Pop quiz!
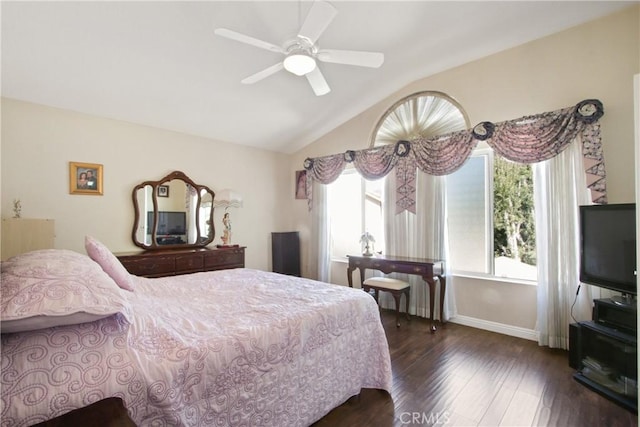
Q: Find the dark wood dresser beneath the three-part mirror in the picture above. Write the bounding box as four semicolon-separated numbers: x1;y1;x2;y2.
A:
115;246;245;277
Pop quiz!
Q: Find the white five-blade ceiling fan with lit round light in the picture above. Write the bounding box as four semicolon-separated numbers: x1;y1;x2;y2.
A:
214;0;384;96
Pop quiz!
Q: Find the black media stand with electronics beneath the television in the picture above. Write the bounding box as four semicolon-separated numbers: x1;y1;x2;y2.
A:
569;300;638;412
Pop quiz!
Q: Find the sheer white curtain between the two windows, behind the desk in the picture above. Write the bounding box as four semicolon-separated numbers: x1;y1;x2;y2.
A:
380;171;456;320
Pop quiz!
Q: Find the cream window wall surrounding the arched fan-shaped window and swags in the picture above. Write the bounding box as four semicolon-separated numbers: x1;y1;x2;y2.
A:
289;5;640;330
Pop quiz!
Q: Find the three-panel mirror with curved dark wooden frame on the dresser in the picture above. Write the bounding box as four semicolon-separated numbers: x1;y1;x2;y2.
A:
132;171;215;250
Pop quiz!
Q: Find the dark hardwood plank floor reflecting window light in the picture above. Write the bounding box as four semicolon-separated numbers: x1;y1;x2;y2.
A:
314;310;638;427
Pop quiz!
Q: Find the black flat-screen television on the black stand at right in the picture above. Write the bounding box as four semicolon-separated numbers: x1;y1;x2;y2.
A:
580;203;637;297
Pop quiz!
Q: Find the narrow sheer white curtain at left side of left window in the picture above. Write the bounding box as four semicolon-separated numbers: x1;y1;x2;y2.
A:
308;181;331;282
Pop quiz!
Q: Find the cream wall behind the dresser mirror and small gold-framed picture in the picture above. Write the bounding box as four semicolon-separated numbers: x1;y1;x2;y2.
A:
1;99;293;270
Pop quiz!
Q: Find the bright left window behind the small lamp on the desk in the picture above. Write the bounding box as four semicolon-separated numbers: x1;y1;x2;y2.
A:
327;169;384;260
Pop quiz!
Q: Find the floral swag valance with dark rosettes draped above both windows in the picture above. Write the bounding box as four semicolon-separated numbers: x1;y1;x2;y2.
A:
304;99;607;213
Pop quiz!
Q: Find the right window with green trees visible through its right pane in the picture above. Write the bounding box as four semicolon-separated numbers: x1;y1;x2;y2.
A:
446;145;537;281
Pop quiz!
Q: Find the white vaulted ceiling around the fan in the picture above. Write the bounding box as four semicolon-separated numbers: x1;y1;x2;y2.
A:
1;1;633;153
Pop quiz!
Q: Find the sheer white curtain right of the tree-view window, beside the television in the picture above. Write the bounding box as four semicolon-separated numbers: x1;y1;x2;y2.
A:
534;137;599;349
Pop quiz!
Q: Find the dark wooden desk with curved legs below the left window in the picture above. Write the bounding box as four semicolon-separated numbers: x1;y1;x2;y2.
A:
347;255;446;332
